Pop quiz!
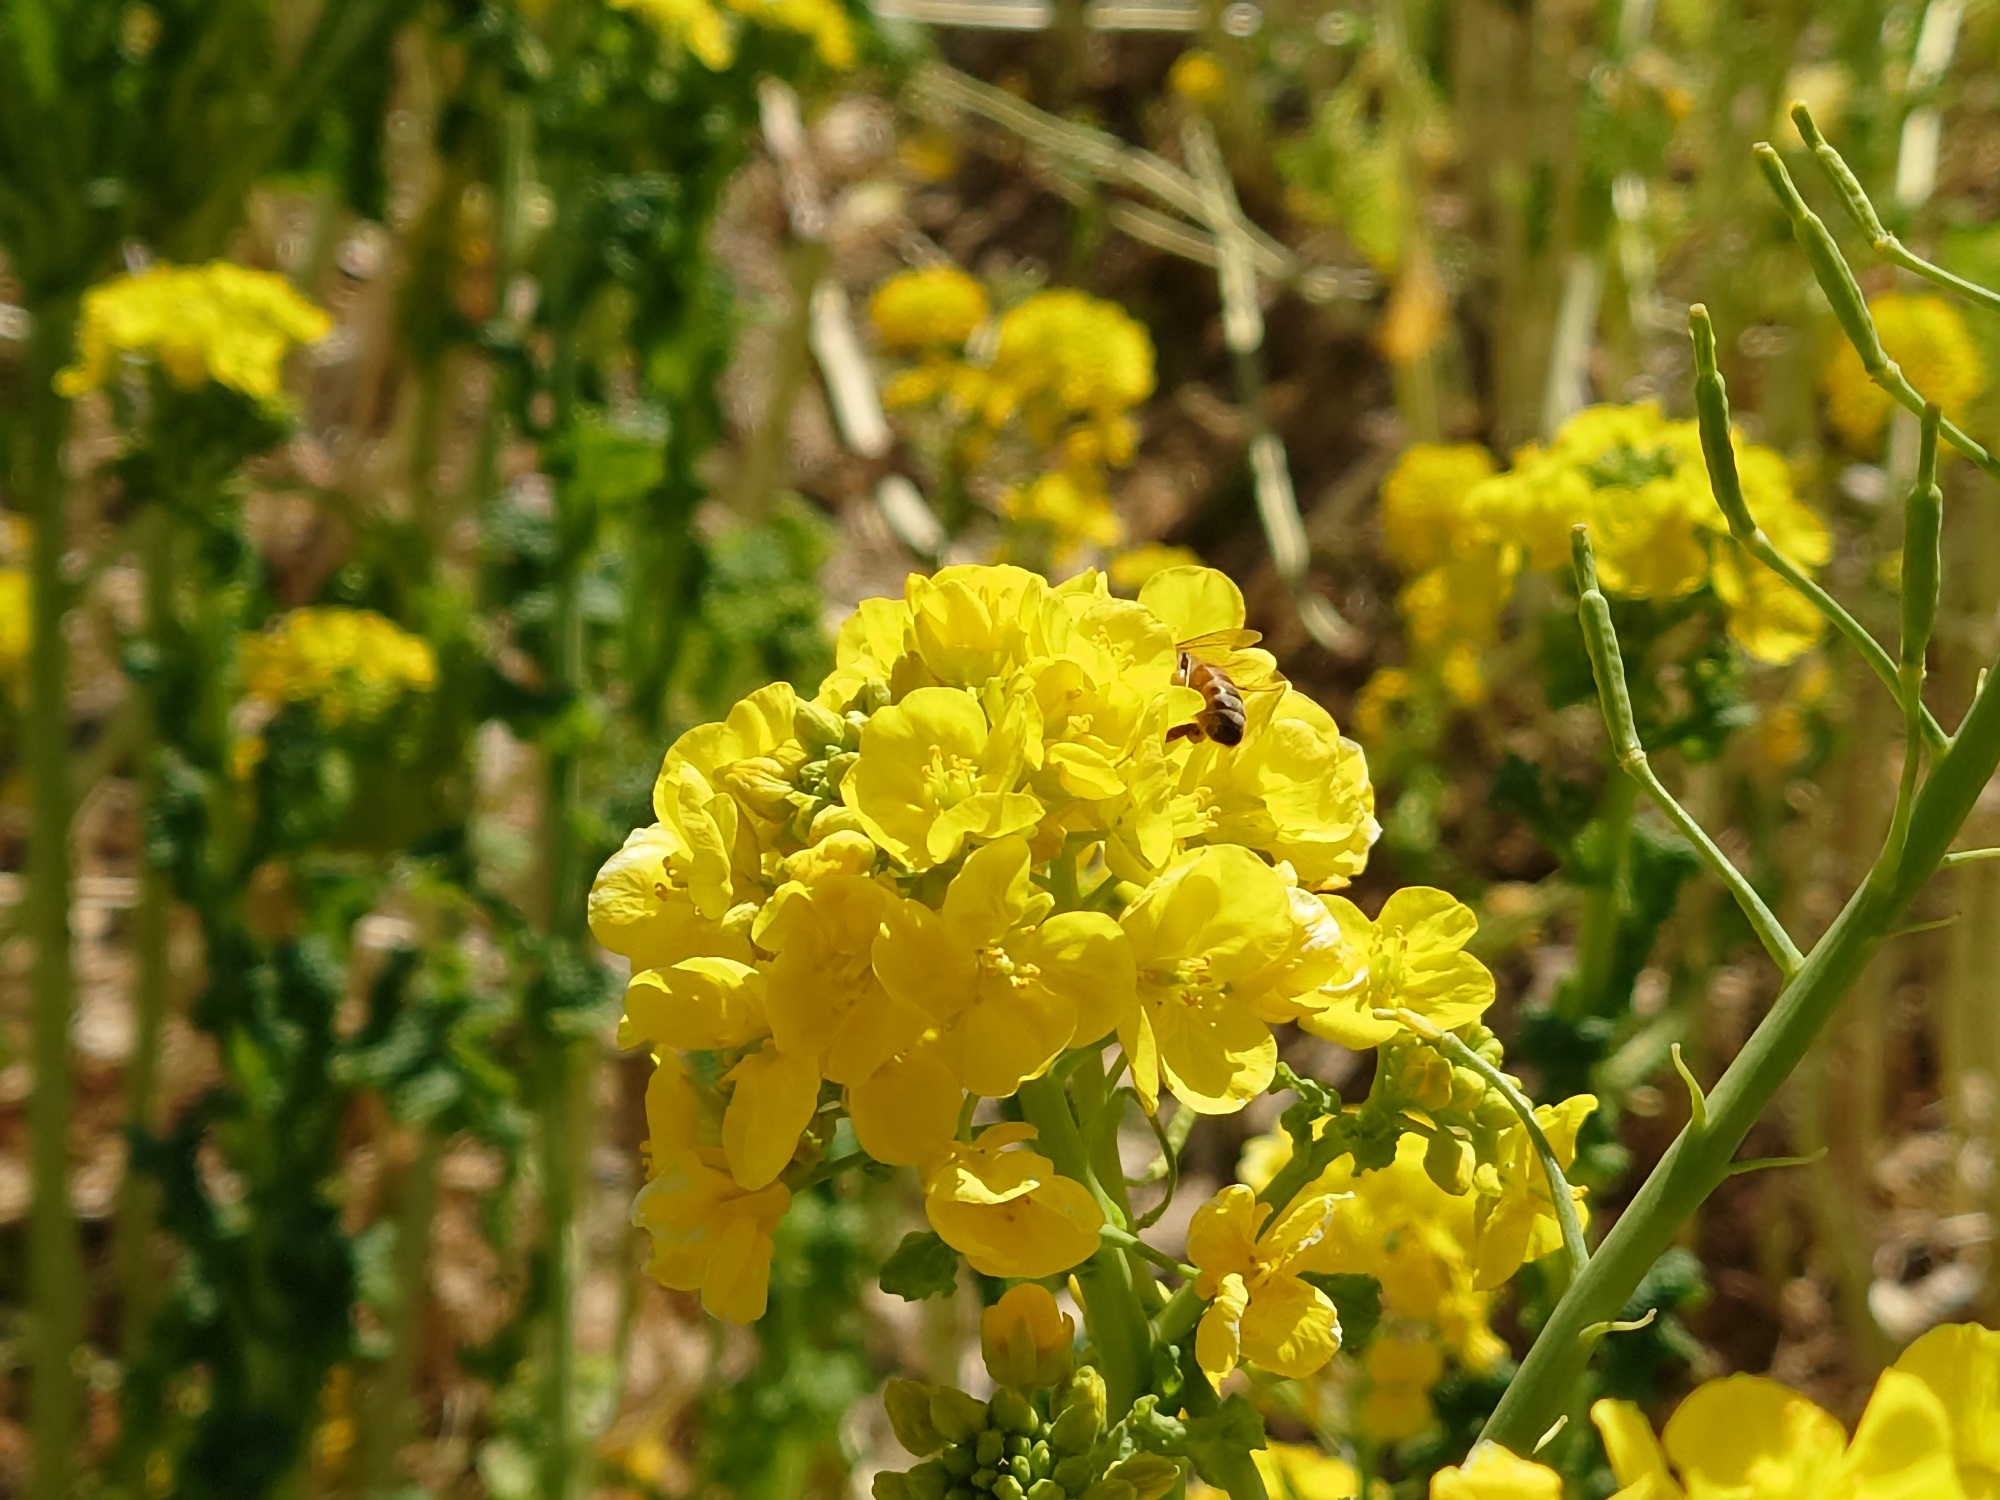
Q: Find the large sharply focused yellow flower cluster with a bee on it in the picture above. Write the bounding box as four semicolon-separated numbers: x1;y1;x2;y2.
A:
590;566;1392;1320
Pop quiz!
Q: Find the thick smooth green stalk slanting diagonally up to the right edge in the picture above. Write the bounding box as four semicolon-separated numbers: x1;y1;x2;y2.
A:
1484;644;2000;1452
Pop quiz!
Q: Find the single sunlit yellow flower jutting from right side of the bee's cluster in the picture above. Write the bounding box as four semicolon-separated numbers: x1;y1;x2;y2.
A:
1300;886;1494;1048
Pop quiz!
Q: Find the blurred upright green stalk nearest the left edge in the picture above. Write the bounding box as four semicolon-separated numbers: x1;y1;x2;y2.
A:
20;312;84;1500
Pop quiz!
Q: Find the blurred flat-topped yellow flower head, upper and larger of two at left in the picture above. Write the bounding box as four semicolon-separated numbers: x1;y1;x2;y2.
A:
56;260;334;404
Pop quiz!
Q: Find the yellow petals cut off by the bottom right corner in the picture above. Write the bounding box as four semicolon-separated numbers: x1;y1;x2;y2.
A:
1430;1324;2000;1500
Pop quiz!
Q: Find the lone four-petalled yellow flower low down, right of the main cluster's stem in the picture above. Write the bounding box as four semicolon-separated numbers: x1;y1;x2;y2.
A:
1188;1182;1340;1382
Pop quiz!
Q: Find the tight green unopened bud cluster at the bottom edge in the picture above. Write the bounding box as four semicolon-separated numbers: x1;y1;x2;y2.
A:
874;1366;1182;1500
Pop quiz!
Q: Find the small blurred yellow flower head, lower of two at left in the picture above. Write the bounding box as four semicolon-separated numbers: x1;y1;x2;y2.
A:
242;606;438;724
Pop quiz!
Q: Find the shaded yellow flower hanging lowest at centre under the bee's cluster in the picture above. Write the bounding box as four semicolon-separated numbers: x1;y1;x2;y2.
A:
924;1124;1104;1280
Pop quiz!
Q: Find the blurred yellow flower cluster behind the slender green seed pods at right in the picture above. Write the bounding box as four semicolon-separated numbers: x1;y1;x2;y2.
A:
1356;402;1832;732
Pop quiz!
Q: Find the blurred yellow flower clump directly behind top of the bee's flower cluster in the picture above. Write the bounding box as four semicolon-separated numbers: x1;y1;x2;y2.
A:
868;266;1154;564
